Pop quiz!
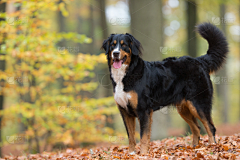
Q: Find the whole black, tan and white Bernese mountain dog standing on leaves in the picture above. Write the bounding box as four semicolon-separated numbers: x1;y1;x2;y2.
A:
102;23;228;154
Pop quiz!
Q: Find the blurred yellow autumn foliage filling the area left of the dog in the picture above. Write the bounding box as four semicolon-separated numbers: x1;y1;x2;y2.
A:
0;0;117;151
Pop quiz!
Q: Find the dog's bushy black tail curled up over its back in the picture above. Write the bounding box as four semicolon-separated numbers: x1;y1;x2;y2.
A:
197;23;228;73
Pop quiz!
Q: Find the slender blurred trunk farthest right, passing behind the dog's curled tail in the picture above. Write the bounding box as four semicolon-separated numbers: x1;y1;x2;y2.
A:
217;4;229;123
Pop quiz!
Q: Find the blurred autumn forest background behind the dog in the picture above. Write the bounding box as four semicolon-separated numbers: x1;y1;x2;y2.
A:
0;0;240;156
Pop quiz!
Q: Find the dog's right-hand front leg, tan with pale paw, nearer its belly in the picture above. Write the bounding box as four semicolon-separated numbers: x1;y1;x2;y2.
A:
138;111;153;154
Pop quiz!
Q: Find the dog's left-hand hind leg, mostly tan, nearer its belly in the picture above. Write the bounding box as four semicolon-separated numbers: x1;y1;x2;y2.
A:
177;101;200;146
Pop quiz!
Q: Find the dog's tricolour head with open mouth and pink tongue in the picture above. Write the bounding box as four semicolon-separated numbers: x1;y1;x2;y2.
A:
102;33;142;69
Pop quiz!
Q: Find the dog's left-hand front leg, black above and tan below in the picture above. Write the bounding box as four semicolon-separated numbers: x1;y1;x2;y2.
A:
118;106;136;153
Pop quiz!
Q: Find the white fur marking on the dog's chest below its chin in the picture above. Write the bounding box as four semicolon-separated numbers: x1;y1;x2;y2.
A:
111;64;131;109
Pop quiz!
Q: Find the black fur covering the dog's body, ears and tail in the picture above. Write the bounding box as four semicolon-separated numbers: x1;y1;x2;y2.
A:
103;23;228;152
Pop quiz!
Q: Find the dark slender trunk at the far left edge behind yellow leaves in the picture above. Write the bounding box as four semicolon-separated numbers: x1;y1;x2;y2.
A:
0;3;6;157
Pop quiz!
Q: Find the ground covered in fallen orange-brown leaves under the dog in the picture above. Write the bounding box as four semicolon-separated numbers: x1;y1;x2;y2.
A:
5;134;240;160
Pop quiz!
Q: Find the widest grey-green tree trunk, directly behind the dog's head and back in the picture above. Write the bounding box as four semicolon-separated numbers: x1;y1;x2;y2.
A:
129;0;167;140
